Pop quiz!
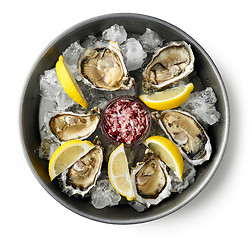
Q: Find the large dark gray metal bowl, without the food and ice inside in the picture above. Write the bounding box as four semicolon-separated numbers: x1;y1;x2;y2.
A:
21;14;229;224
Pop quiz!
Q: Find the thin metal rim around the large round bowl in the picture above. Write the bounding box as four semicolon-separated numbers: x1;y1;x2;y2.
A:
19;13;230;224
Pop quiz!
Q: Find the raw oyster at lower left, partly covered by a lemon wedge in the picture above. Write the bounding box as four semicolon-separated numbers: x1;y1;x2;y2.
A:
59;136;103;197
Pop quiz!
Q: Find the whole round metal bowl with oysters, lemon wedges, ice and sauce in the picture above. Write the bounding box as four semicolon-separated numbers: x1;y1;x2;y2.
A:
21;14;229;224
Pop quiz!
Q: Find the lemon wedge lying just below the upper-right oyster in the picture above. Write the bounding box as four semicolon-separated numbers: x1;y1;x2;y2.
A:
139;83;194;110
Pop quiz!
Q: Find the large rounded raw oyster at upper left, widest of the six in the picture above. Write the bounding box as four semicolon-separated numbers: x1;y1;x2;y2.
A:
78;41;135;91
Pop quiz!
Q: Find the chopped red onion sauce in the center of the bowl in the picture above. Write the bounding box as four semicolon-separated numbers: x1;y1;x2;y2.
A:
104;99;149;144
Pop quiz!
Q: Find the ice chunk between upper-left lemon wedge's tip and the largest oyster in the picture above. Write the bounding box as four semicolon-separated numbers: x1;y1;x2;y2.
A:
62;41;83;66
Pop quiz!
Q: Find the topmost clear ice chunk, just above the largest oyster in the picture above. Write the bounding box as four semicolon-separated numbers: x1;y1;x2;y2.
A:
102;24;127;45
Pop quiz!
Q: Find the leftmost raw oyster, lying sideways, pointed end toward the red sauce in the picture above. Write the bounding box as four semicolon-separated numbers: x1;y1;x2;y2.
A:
45;107;100;143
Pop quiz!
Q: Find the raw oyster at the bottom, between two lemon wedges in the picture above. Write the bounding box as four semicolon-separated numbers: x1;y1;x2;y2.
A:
131;149;171;207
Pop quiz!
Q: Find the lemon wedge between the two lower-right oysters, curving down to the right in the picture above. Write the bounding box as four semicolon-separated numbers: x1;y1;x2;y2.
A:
143;136;184;180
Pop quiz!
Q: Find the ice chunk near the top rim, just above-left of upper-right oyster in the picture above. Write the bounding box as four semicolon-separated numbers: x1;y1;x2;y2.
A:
139;28;163;52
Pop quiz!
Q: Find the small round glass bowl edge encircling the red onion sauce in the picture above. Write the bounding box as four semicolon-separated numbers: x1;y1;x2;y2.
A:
101;96;151;148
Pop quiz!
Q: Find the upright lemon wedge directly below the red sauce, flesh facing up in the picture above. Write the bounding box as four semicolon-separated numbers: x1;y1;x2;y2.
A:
108;143;135;201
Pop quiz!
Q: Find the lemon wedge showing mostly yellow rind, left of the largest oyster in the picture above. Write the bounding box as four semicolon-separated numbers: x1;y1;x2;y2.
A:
56;55;88;108
